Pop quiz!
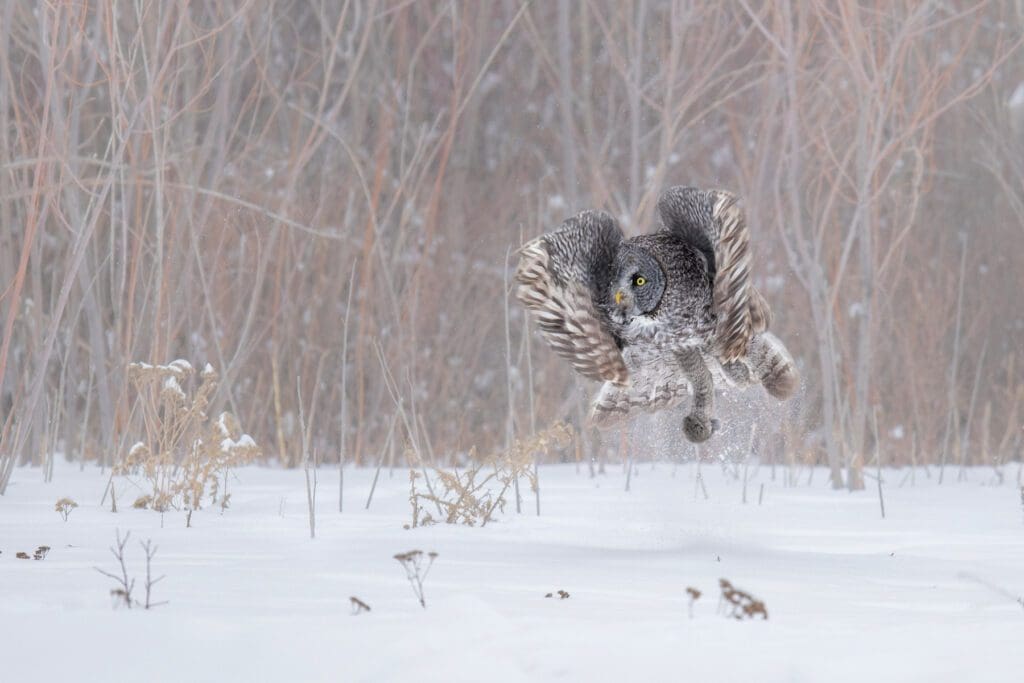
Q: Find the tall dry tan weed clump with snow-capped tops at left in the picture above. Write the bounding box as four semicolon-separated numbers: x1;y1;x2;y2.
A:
115;359;260;523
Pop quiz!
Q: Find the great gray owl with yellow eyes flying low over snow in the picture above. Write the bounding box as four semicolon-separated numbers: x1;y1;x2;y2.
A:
516;187;800;442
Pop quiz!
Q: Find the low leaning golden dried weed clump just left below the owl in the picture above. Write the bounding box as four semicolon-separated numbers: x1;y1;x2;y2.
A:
407;422;573;528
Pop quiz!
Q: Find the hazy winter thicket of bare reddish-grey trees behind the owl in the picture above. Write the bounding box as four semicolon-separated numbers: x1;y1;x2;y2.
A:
0;0;1024;496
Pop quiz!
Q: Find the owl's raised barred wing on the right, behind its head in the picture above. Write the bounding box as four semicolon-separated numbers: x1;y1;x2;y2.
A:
657;186;771;362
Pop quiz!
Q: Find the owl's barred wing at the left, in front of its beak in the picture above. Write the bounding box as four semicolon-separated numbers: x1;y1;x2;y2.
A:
515;211;629;384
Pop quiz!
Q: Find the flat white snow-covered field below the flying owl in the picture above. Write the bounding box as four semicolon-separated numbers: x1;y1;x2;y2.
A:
0;464;1024;683
